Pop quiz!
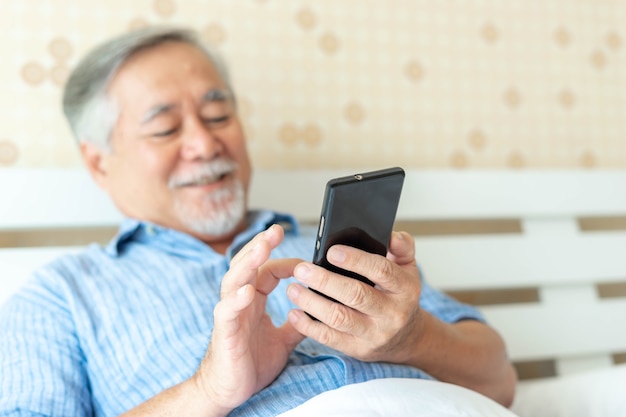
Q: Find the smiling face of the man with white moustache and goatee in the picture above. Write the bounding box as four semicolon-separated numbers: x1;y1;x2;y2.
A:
91;42;251;243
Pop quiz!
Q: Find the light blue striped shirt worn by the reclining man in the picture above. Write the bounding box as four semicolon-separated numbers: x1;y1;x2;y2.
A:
0;211;481;416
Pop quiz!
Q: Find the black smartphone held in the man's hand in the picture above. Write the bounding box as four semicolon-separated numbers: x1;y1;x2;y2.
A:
313;167;404;292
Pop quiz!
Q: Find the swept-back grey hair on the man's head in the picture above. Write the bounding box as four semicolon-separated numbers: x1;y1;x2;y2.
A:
63;26;234;150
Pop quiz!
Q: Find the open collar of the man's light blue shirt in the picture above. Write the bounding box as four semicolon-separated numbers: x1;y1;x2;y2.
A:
105;210;300;259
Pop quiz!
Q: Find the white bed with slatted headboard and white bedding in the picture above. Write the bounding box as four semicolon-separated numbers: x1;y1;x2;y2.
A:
0;169;626;417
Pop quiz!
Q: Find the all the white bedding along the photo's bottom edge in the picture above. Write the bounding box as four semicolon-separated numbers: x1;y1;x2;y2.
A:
280;364;626;417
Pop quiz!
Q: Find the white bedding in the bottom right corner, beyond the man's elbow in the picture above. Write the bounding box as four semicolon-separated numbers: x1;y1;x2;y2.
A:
512;365;626;417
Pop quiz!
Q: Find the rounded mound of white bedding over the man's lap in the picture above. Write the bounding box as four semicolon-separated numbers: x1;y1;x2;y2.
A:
280;378;515;417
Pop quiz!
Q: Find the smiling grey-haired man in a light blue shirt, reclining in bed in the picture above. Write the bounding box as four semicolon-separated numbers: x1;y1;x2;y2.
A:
0;28;515;416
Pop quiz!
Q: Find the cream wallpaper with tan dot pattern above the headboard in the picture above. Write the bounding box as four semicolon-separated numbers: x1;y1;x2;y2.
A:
0;0;626;169
